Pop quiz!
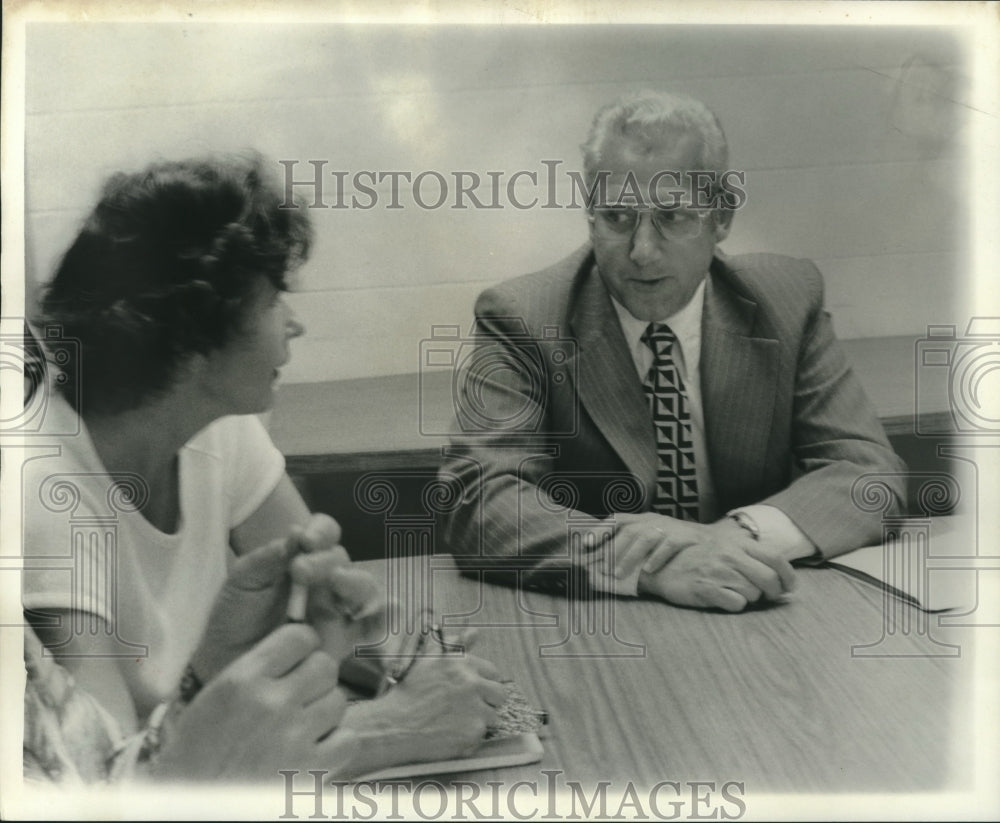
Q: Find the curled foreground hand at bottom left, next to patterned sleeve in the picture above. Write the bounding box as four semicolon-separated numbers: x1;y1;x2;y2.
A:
151;624;347;782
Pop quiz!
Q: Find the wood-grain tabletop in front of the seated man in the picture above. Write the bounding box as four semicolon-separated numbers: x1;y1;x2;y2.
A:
356;555;972;796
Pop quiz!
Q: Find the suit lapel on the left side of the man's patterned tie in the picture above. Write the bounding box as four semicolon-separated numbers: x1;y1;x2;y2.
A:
570;255;656;493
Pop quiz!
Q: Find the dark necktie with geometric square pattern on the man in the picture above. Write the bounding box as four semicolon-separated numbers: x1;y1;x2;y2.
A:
642;323;698;520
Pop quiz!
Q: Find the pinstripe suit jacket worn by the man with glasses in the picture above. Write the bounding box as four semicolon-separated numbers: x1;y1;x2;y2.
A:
441;247;905;577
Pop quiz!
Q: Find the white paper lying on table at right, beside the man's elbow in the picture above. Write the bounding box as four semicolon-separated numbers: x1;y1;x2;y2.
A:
828;516;977;612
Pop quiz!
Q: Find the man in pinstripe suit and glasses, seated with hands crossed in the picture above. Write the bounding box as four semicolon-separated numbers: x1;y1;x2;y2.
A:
442;92;905;612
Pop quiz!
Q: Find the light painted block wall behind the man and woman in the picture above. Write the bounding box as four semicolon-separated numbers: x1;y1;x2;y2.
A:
26;23;969;382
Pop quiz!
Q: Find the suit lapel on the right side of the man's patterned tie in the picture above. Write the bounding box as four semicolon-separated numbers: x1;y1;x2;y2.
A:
701;258;779;508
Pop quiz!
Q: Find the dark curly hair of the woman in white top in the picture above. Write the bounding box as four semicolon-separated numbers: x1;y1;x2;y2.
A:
41;155;312;414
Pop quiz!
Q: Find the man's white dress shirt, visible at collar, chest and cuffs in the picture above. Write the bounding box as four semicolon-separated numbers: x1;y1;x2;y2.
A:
611;276;815;594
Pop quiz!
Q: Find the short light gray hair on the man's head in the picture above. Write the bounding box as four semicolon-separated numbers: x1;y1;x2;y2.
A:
580;90;729;184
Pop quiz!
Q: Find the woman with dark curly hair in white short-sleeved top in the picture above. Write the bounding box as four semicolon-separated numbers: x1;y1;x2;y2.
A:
23;157;504;773
